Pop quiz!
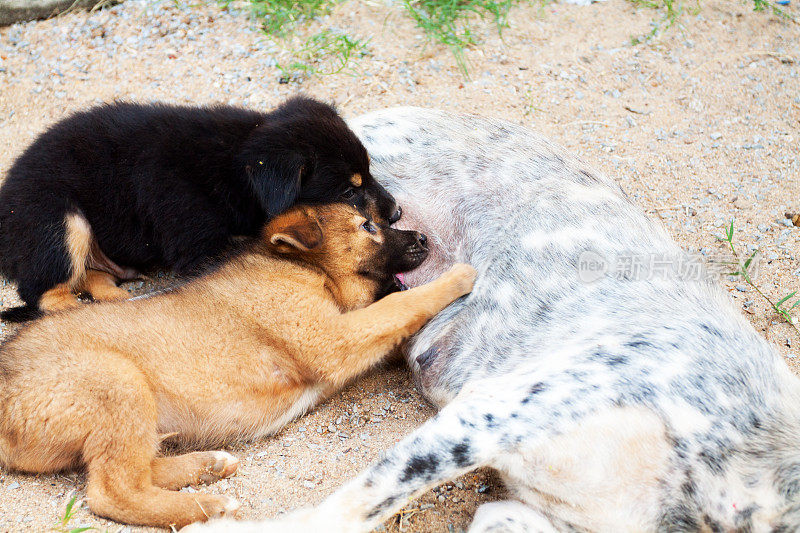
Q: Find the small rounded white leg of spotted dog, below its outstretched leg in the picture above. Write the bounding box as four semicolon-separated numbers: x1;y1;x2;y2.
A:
468;501;559;533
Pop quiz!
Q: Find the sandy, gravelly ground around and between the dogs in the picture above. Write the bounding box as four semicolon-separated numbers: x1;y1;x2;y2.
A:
0;0;800;532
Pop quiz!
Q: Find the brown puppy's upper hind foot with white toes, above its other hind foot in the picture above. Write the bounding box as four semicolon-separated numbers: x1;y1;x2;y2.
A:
151;451;239;490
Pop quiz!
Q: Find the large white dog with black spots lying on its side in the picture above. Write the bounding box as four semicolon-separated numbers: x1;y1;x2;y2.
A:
184;108;800;533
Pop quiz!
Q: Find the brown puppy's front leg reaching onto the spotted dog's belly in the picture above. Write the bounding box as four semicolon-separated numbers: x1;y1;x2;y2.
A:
314;264;477;386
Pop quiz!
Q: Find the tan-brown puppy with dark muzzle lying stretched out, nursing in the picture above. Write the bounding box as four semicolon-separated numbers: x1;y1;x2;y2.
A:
0;205;475;527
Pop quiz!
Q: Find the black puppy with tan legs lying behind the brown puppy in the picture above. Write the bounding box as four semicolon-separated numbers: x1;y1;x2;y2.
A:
0;97;400;321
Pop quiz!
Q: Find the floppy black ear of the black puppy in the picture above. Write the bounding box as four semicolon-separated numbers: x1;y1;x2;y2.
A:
245;153;306;218
